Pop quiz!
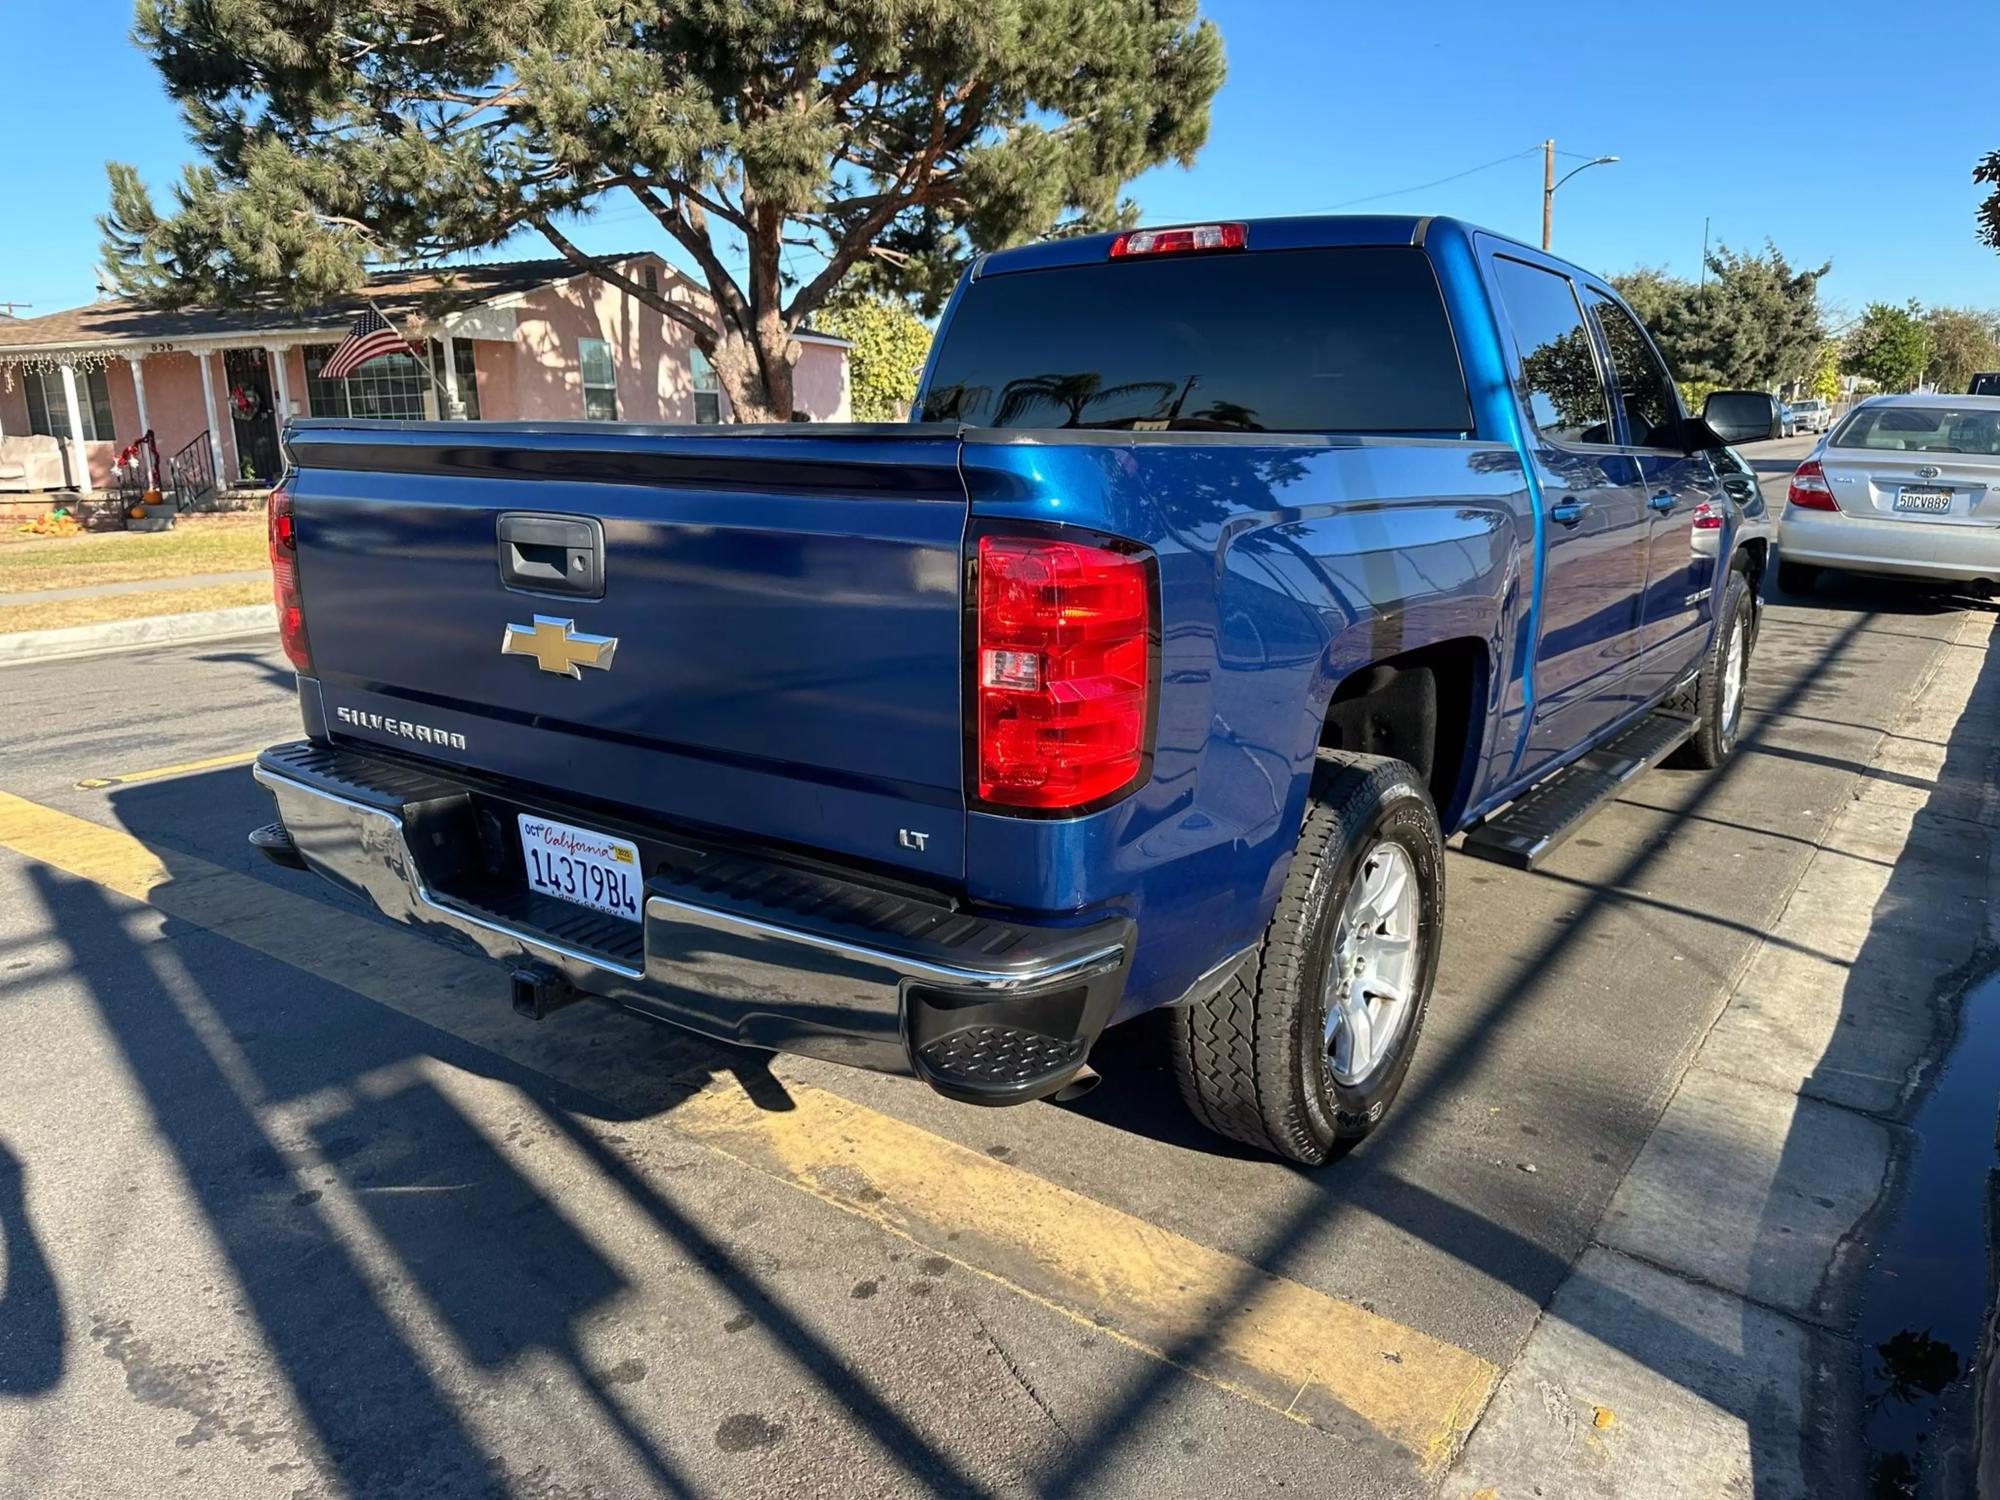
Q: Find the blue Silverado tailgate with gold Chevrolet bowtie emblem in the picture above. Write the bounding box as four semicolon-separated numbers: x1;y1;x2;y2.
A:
290;422;966;880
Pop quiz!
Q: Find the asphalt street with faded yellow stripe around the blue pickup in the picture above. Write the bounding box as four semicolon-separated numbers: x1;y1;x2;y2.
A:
0;442;1976;1500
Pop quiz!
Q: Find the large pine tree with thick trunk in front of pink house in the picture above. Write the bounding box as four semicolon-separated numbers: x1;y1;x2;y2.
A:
102;0;1224;418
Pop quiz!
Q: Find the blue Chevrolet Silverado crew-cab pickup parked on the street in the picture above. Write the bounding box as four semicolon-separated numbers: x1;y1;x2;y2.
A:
252;218;1780;1162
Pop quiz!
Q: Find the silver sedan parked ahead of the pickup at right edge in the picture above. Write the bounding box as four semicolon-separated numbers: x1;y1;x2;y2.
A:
1778;396;2000;594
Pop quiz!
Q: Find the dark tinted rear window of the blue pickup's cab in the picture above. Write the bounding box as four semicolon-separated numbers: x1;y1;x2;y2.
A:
922;246;1472;436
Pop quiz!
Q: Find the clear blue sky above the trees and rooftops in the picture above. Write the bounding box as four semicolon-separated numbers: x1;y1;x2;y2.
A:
0;0;2000;316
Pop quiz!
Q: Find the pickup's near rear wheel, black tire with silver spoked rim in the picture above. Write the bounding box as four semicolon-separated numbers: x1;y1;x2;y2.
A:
1172;752;1444;1166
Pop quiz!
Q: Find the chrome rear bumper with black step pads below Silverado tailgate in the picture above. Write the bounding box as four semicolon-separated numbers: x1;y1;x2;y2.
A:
256;742;1132;1104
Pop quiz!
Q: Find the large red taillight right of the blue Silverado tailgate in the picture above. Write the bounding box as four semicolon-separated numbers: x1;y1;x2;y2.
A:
974;536;1158;810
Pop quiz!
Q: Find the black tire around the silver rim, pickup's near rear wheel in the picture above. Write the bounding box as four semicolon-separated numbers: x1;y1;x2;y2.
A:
1170;750;1444;1166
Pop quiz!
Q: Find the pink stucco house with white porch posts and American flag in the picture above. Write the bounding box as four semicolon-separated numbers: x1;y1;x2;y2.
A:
0;254;850;490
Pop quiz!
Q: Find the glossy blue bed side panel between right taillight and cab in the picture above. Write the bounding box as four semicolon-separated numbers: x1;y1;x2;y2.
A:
962;432;1532;1014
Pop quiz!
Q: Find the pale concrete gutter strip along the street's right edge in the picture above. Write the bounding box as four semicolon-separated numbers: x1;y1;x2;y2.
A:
1444;614;2000;1500
